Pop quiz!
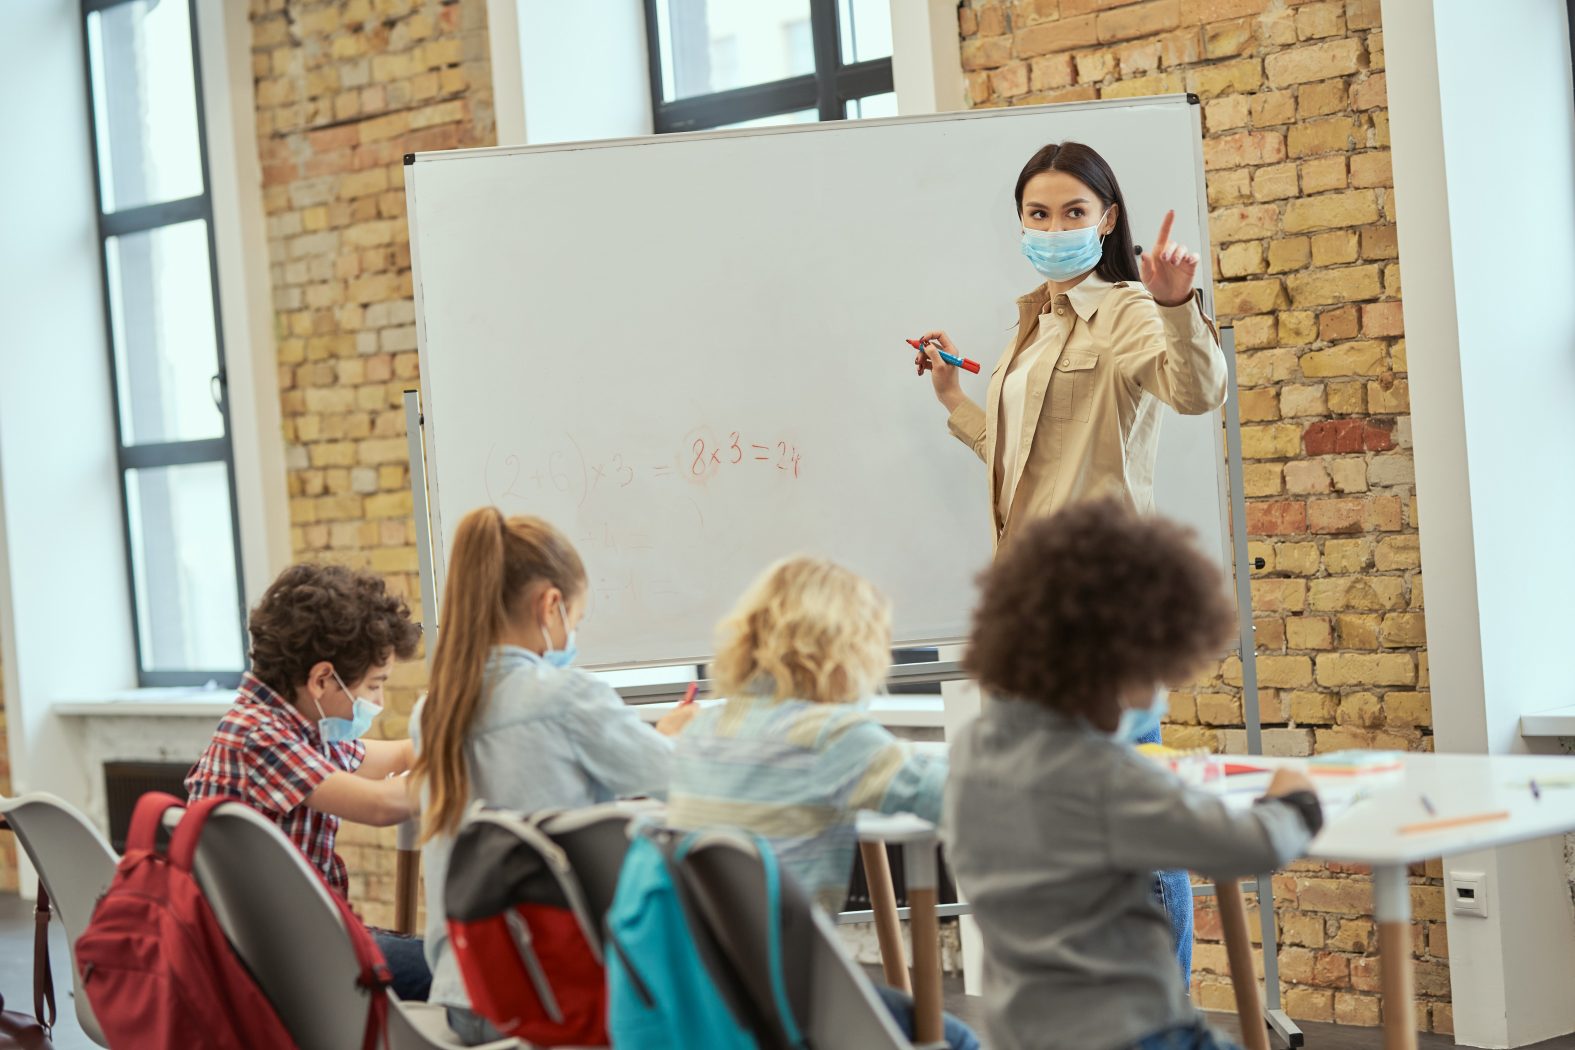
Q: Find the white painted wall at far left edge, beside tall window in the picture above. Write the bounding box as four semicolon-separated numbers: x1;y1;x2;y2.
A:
0;0;135;803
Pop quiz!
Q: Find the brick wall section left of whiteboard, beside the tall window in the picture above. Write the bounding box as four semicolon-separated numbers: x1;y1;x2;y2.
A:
250;0;496;924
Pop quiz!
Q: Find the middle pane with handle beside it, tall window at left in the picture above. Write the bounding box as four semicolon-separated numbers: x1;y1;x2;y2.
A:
104;219;224;446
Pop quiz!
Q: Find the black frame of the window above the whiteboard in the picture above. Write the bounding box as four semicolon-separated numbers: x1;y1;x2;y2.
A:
644;0;895;135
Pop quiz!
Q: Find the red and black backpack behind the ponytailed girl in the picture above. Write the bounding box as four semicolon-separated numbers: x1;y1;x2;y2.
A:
443;808;608;1047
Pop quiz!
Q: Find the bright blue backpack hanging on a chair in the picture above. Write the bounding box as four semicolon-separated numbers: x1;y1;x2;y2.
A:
606;828;805;1050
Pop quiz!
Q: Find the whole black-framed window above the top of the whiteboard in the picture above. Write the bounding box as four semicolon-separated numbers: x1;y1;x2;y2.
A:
646;0;896;132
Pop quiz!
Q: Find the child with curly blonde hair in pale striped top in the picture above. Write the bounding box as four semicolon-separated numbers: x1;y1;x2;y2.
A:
668;557;978;1048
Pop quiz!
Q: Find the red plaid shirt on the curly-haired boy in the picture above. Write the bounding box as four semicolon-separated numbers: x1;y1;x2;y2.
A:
186;672;367;894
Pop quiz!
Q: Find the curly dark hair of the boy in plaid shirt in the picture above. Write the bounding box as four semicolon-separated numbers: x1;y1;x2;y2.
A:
249;562;421;696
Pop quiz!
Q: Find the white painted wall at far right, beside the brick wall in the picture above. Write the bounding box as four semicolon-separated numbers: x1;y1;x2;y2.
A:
1383;0;1575;1047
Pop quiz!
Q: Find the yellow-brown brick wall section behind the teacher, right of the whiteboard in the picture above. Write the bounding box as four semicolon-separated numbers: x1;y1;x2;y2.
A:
958;0;1452;1033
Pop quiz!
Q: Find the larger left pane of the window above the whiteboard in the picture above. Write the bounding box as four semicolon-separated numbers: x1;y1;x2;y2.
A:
657;0;812;102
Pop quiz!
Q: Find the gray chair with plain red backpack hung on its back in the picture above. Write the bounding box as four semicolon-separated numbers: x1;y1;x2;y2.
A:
195;803;520;1050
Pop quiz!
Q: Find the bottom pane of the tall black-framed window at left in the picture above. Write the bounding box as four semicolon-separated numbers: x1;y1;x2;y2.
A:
126;463;244;671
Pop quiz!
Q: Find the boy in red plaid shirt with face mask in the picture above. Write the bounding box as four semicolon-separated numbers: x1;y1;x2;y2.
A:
186;564;432;1000
